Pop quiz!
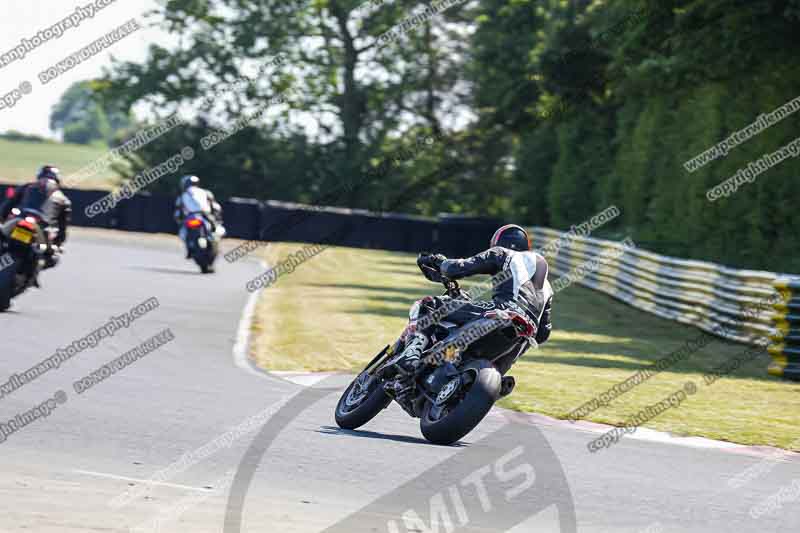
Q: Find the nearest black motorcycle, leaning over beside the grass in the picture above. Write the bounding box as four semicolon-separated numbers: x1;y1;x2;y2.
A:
335;267;536;444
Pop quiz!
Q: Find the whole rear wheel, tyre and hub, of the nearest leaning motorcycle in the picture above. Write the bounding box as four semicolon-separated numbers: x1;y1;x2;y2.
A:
419;359;502;444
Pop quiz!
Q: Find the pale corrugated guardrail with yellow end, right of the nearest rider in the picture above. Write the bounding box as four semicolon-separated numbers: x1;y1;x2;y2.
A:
531;227;800;379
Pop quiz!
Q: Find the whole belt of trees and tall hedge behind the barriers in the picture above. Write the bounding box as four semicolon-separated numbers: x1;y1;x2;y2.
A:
97;0;800;272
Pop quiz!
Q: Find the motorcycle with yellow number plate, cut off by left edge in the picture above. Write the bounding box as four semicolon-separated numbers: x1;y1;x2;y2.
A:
0;208;49;312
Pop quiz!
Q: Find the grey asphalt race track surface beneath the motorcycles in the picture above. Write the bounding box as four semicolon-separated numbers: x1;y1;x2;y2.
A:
0;231;800;533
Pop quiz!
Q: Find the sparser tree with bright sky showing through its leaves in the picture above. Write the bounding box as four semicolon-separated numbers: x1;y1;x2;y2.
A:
104;0;476;206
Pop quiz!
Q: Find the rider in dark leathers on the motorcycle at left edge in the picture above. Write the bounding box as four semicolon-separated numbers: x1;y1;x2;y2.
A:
0;165;72;268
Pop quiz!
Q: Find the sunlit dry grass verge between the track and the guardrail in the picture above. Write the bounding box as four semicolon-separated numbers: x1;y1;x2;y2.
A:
251;244;800;451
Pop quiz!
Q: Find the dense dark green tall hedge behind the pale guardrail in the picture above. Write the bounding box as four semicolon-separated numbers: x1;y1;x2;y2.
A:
468;0;800;272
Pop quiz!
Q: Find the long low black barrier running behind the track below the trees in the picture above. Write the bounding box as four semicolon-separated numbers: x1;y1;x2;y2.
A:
0;184;502;257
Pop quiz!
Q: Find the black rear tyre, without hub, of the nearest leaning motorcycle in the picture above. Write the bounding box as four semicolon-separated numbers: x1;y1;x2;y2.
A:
419;359;501;444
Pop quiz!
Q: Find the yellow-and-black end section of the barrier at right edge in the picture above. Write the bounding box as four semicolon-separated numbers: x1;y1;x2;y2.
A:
769;278;800;380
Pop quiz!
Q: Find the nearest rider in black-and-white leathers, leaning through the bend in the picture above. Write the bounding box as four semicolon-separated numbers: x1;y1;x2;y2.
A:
386;224;553;404
